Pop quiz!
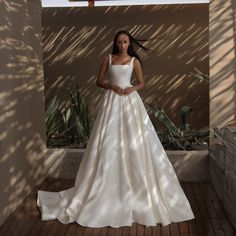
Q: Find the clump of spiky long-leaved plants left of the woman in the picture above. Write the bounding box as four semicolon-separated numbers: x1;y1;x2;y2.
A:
46;84;93;147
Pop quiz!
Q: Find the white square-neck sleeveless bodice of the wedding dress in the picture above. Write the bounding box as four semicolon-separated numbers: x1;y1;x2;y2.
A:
108;54;134;87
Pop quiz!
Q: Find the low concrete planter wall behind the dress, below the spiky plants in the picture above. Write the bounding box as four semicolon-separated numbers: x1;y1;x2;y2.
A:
44;148;209;182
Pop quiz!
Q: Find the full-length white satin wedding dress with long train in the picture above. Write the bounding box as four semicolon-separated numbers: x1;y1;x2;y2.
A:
37;55;194;228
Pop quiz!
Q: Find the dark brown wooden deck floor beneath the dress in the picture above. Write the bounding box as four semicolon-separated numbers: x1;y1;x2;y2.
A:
0;179;236;236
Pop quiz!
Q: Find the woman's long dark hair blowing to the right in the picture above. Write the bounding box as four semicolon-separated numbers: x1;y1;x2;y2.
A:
112;30;151;65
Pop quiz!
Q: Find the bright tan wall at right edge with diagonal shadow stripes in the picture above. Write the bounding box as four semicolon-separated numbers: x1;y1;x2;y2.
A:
209;0;236;127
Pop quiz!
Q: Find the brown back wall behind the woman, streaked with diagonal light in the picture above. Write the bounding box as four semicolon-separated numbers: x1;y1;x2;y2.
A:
42;4;209;128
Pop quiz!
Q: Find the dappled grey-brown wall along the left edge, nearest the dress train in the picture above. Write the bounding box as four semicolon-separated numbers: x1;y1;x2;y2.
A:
0;0;45;225
